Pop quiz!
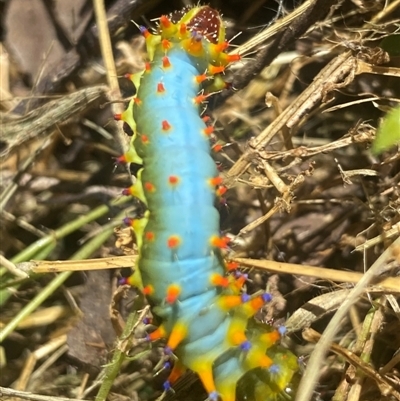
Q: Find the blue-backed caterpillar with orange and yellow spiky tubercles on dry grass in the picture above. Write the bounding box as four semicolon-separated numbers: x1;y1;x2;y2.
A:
116;6;298;401
